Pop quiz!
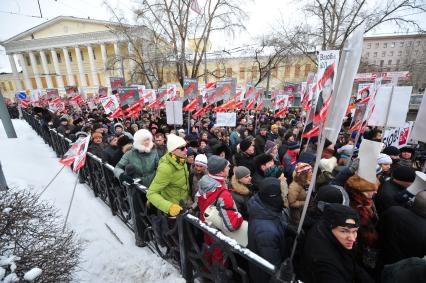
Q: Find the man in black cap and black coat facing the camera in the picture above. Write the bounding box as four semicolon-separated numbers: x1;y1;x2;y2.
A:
302;204;374;283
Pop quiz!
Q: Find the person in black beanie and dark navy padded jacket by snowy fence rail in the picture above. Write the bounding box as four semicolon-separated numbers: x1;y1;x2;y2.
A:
247;177;289;282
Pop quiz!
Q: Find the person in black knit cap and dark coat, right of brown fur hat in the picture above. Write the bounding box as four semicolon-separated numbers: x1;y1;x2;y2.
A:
374;166;416;216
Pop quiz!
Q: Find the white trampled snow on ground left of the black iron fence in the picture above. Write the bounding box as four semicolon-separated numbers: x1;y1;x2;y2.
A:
0;120;184;282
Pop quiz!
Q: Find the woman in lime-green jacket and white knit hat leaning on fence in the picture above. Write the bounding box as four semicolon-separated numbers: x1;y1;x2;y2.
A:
147;134;189;216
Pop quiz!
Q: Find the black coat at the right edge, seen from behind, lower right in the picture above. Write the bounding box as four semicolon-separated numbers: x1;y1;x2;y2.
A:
378;206;426;264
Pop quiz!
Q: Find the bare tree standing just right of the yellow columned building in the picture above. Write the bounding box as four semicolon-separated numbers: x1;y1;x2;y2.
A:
135;0;246;85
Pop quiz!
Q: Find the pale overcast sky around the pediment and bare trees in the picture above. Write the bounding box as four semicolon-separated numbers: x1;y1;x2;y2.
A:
0;0;426;72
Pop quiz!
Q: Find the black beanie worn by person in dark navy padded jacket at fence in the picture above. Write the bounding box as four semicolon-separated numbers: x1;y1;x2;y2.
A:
258;177;284;211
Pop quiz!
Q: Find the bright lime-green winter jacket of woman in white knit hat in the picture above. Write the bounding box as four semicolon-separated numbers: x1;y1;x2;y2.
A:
146;152;189;213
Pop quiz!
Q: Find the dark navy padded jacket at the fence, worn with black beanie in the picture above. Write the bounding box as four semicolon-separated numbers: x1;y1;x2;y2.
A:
247;195;289;283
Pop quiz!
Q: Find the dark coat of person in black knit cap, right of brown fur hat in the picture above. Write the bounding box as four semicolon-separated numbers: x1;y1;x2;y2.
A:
374;179;405;216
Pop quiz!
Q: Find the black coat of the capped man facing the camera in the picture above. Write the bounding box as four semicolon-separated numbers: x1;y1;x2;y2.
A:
302;220;374;283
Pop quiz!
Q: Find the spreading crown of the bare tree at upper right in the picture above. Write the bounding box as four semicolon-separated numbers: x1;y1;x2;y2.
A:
274;0;426;64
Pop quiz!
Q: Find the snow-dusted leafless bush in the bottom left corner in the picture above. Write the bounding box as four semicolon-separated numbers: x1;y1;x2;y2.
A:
0;189;82;282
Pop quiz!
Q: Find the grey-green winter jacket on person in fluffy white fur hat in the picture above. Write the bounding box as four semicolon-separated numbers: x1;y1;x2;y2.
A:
114;148;159;188
